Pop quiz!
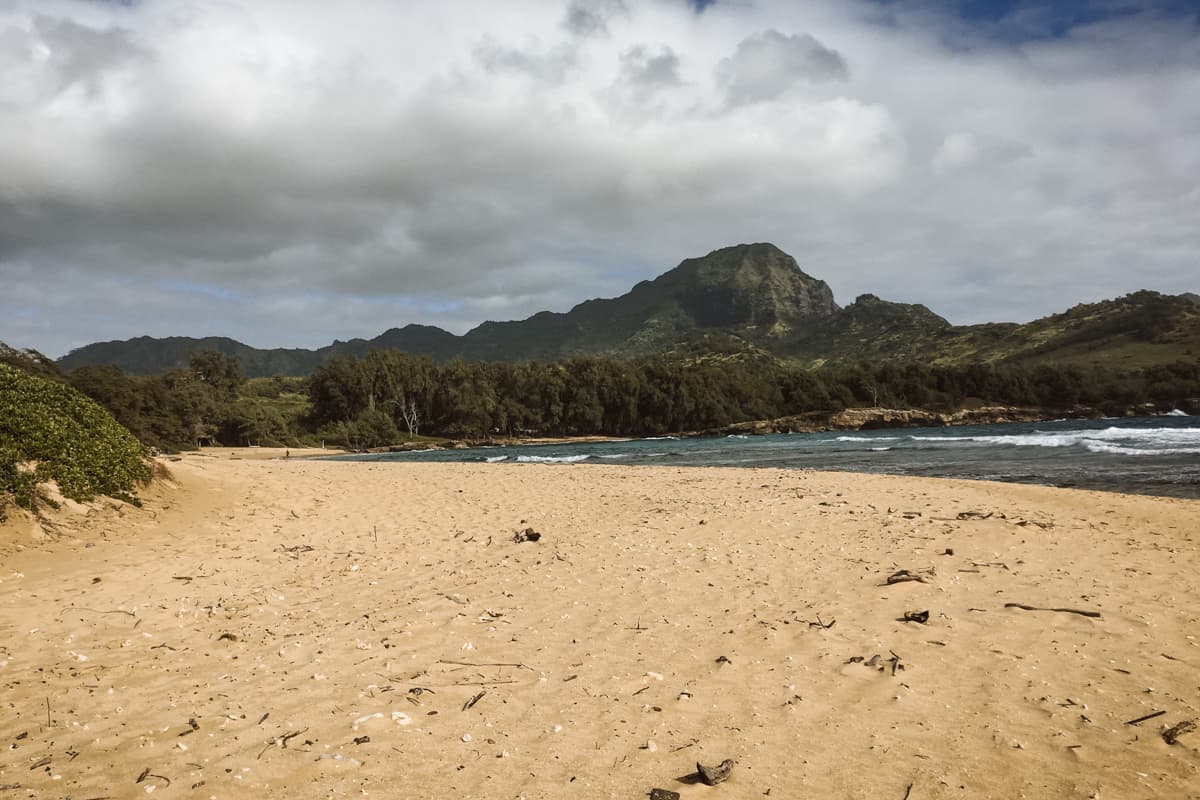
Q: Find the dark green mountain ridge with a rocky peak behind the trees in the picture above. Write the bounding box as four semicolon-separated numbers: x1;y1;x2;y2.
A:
51;242;1200;377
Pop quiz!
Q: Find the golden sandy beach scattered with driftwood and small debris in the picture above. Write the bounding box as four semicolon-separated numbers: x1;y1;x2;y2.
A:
0;452;1200;800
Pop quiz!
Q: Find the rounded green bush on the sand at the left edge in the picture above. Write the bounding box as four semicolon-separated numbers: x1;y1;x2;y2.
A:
0;363;151;513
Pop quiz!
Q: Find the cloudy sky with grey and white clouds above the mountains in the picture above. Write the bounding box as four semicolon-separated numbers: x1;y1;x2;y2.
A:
0;0;1200;356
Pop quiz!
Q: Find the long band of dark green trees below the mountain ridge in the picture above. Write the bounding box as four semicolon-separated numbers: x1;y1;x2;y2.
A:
30;350;1200;450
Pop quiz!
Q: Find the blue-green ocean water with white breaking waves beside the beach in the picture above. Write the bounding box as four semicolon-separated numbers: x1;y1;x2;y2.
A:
328;416;1200;498
